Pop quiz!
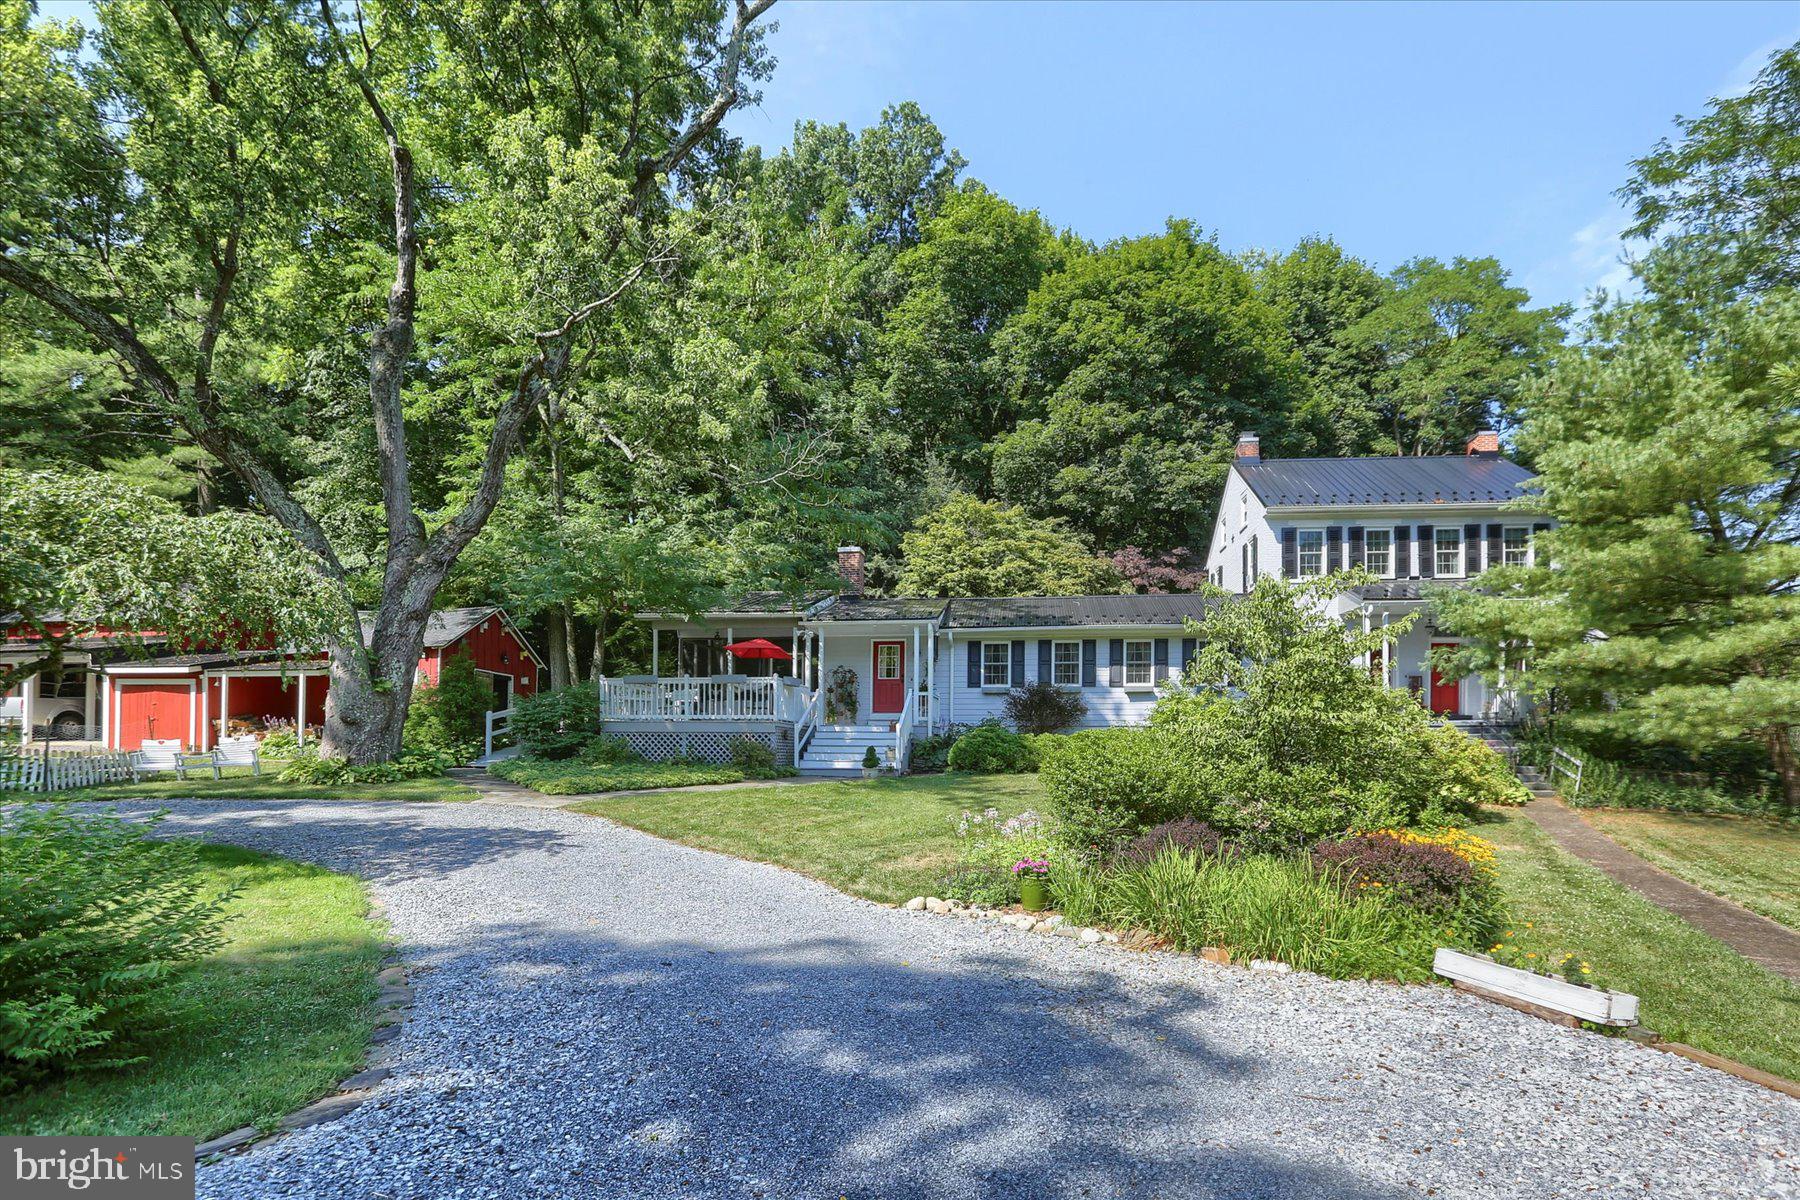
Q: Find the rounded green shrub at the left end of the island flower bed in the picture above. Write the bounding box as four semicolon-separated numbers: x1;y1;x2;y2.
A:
1039;729;1192;856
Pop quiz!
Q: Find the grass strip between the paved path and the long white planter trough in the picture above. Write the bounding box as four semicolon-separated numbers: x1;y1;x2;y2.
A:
1474;811;1800;1079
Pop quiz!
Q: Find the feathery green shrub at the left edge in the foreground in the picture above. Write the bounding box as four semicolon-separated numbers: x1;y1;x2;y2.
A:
0;806;229;1090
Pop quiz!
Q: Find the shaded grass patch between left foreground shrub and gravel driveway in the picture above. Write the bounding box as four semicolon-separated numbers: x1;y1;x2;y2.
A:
0;846;383;1139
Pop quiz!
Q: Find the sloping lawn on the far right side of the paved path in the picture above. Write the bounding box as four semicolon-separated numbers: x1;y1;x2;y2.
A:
1582;808;1800;928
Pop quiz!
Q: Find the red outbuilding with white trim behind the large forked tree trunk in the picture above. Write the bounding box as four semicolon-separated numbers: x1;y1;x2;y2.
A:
0;604;544;750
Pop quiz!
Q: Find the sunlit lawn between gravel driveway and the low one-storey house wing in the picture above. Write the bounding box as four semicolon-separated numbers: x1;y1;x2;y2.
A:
571;772;1039;903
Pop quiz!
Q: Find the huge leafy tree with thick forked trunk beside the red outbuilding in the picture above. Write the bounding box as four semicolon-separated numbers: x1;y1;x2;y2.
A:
0;0;772;761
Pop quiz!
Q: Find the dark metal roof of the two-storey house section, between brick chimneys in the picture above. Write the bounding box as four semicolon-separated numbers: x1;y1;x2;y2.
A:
1233;453;1532;507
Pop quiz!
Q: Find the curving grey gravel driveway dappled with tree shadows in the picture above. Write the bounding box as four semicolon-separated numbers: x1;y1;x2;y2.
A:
126;801;1800;1200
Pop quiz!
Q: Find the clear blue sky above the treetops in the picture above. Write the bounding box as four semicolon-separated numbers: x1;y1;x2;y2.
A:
729;0;1800;302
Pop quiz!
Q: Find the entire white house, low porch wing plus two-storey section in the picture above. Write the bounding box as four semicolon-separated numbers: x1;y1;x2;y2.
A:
622;432;1548;774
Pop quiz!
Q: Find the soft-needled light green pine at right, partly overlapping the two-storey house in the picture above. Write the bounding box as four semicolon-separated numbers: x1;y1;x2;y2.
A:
1436;295;1800;808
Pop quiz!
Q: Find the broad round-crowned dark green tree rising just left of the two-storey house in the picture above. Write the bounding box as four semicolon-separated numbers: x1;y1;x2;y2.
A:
994;221;1303;551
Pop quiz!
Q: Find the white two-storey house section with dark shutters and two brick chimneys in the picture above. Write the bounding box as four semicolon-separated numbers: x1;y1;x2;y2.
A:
1206;432;1550;720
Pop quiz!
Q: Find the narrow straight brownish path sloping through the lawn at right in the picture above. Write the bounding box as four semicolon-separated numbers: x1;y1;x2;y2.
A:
1525;799;1800;982
